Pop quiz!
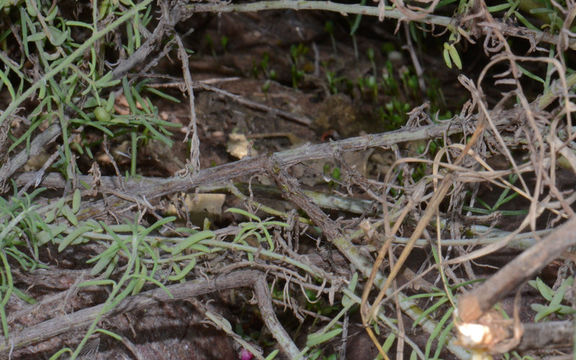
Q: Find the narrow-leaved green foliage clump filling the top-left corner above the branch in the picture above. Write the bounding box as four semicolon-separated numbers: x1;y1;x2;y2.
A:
0;0;180;178
